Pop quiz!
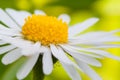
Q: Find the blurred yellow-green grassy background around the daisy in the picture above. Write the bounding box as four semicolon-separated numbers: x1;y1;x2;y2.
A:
0;0;120;80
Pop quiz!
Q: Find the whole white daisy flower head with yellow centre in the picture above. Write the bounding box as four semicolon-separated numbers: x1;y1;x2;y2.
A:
0;9;120;80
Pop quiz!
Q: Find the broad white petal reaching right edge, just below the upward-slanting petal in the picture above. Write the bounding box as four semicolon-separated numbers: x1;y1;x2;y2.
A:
69;30;120;45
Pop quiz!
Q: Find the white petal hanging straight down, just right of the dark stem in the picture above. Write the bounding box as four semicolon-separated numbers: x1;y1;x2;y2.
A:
42;49;53;75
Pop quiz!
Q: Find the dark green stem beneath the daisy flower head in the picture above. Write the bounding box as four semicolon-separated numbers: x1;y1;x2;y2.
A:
33;55;44;80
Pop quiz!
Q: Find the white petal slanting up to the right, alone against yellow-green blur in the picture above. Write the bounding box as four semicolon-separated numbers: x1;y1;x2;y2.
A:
68;18;99;36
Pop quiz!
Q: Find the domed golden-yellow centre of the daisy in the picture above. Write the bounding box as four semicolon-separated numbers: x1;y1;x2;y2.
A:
22;15;68;45
